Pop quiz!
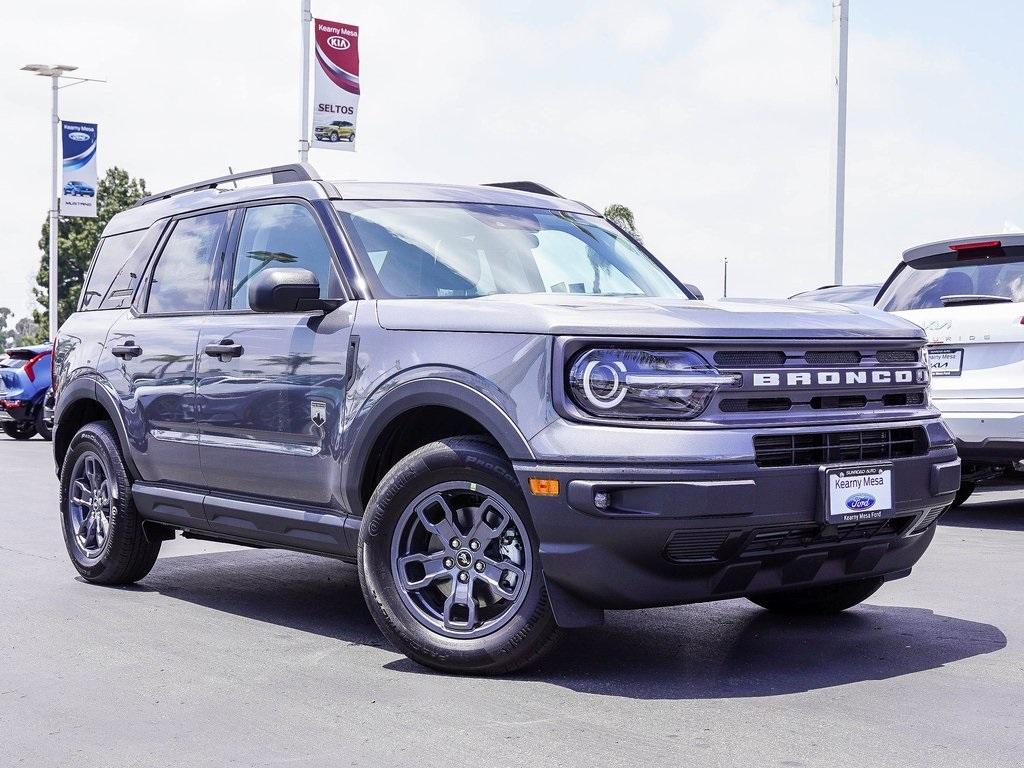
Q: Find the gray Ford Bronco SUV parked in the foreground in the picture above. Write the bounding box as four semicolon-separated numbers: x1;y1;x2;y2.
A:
53;165;959;674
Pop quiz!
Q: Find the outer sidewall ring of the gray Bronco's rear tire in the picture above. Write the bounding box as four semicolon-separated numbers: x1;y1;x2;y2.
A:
60;423;135;580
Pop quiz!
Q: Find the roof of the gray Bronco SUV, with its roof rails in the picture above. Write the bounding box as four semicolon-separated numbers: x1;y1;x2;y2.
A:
103;165;596;236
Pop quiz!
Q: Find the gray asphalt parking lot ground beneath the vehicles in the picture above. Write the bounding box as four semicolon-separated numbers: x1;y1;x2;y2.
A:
0;437;1024;768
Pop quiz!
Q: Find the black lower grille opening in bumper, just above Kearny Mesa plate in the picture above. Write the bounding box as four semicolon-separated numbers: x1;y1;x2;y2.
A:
754;427;928;467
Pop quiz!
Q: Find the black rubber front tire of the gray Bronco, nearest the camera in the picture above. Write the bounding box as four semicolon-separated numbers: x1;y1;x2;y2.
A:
358;437;559;675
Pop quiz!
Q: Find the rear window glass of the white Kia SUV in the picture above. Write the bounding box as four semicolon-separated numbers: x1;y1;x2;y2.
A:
878;247;1024;312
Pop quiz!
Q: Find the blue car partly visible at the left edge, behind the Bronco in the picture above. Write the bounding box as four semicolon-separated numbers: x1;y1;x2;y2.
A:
0;344;53;440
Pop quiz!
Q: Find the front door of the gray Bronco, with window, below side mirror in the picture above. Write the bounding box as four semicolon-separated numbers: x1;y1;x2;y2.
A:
197;203;355;509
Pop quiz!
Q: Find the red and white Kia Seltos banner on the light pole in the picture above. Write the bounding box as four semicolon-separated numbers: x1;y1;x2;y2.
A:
310;18;359;150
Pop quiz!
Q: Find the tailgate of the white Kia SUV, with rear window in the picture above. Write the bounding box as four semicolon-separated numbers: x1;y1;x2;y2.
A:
879;243;1024;399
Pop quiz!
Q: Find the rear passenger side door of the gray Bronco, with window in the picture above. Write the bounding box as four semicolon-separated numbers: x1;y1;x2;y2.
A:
101;210;231;487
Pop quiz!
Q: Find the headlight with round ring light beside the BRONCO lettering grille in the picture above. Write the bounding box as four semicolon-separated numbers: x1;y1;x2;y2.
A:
569;348;739;421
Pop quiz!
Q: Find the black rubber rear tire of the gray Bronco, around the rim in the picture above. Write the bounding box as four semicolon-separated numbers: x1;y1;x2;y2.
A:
60;421;160;585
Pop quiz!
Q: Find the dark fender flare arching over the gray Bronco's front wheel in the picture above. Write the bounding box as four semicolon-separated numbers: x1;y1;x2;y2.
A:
342;372;535;515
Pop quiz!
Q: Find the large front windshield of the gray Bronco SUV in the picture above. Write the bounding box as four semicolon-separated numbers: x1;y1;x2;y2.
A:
338;201;686;298
